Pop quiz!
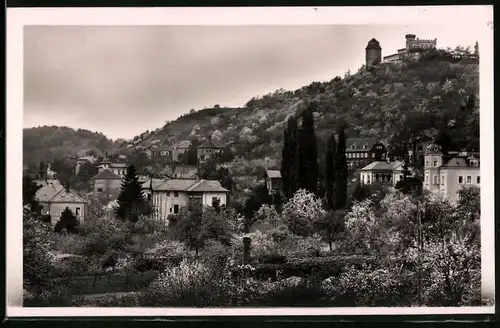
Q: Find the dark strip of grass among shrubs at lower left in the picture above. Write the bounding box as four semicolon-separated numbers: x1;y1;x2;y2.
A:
56;271;158;295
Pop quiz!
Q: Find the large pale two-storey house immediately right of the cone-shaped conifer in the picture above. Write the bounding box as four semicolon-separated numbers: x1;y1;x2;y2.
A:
146;179;229;223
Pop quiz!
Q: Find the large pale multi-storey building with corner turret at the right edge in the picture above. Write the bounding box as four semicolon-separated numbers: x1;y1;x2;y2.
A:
424;143;481;203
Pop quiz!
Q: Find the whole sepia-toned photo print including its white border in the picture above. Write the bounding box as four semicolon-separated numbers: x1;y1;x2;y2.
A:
6;6;495;315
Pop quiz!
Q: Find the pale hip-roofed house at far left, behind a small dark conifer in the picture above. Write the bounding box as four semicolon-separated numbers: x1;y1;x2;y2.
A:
35;182;87;226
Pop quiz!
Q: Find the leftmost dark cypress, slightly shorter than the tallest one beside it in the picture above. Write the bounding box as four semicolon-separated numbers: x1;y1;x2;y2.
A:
281;116;297;198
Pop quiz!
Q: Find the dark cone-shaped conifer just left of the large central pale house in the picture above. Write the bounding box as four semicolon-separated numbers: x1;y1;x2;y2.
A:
116;165;147;222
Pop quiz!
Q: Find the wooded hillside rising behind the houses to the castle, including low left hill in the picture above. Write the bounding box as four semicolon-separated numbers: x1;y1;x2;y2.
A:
24;50;479;185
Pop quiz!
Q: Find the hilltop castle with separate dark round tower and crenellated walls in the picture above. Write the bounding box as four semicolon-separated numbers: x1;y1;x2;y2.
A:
365;34;437;66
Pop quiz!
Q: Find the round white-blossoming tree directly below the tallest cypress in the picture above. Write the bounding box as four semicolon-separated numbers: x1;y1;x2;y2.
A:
283;189;326;236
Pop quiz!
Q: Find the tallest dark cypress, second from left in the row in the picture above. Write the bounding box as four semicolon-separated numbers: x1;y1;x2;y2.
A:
297;103;319;194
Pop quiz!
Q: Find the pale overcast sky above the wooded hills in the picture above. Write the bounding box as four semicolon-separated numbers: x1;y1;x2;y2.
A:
24;25;480;139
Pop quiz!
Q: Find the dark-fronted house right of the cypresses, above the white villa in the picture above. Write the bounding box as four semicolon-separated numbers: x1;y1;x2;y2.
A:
345;138;387;166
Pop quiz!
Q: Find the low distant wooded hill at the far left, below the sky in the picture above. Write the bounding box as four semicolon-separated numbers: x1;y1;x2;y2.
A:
23;126;124;168
